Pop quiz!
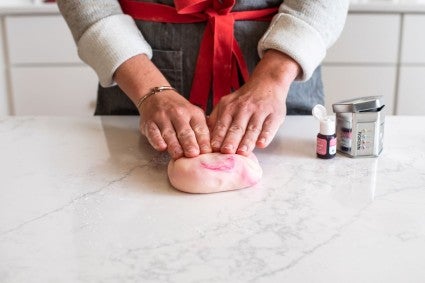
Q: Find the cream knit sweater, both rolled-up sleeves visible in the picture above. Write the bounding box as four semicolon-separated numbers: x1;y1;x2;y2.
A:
57;0;349;87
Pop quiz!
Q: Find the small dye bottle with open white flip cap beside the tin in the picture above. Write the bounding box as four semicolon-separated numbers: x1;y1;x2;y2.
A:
312;104;336;159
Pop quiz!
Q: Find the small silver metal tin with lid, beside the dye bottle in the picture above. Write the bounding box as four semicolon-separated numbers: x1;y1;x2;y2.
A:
332;96;385;157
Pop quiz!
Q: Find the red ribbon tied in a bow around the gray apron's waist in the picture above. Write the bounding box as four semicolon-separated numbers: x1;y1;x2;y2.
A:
119;0;277;110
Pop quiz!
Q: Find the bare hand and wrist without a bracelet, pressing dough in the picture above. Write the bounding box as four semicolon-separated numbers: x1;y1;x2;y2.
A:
208;50;300;158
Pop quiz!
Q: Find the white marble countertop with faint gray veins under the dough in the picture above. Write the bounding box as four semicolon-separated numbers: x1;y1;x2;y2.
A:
0;116;425;283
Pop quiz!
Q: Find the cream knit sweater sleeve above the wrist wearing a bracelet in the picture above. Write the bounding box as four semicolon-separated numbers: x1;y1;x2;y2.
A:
57;0;152;87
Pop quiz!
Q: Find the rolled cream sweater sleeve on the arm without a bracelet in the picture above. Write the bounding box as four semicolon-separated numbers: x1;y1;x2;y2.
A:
258;0;349;81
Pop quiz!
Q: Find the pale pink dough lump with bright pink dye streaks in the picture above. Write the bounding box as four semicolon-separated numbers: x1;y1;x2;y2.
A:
168;153;263;194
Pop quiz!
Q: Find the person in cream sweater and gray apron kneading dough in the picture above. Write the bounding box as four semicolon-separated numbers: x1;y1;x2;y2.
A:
58;0;348;159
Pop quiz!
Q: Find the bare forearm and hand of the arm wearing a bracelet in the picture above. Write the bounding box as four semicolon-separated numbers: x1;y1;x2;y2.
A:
114;54;211;159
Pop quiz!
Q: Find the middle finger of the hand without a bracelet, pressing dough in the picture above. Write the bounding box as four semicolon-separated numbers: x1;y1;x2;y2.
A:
221;113;251;153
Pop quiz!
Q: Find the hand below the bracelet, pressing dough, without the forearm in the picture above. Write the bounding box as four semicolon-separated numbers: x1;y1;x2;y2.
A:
139;90;211;159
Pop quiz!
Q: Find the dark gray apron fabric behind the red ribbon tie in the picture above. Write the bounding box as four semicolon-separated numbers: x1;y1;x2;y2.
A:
95;0;324;115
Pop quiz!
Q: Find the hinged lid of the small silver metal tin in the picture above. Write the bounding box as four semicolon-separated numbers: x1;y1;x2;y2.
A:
332;96;385;113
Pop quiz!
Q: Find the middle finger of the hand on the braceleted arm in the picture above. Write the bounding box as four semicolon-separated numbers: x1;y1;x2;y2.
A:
173;119;199;157
